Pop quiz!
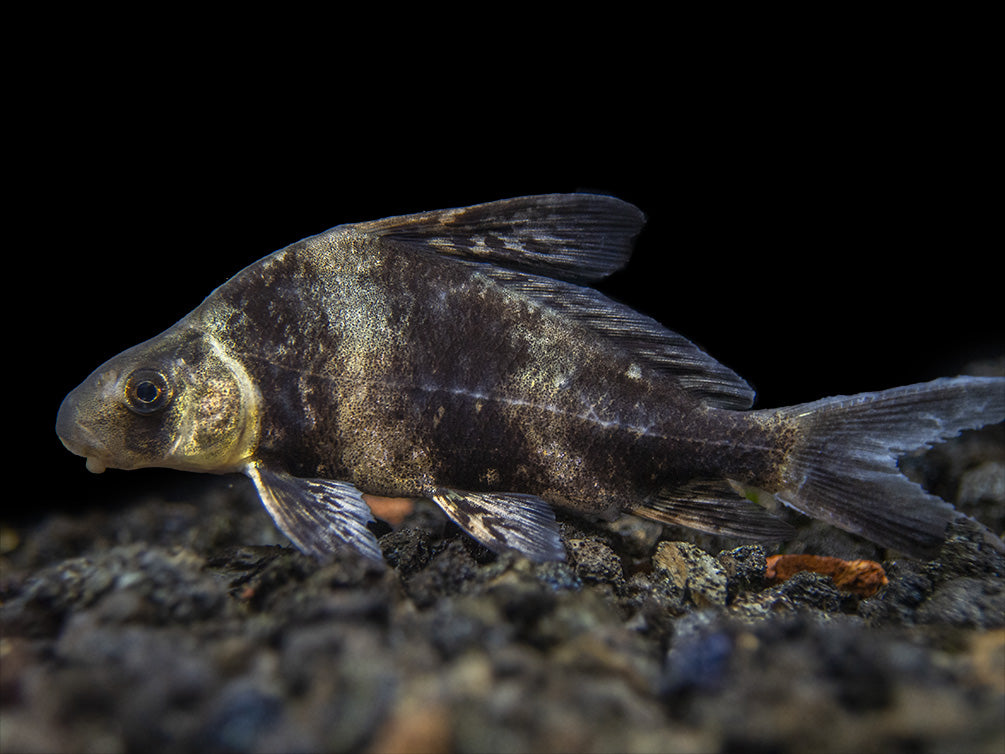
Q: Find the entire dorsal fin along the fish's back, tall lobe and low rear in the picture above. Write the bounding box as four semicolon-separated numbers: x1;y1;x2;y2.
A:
351;194;754;409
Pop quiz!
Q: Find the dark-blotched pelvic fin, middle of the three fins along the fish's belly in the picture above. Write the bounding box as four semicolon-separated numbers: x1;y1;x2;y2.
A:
430;490;565;562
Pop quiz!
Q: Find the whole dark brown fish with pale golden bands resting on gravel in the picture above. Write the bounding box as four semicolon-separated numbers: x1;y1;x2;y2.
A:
55;193;1005;562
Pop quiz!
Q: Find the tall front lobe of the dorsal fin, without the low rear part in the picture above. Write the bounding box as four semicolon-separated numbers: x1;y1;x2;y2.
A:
352;194;645;282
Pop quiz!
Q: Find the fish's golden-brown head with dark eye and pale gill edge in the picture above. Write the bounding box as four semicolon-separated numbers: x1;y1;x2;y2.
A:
56;326;259;474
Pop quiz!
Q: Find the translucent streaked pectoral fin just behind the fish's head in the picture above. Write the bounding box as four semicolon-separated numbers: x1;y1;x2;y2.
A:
244;463;383;562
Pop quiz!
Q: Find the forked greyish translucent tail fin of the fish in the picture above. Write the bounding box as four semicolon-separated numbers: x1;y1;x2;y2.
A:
776;377;1005;557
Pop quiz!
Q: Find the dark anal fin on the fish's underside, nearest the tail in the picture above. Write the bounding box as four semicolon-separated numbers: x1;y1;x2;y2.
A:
628;480;794;542
